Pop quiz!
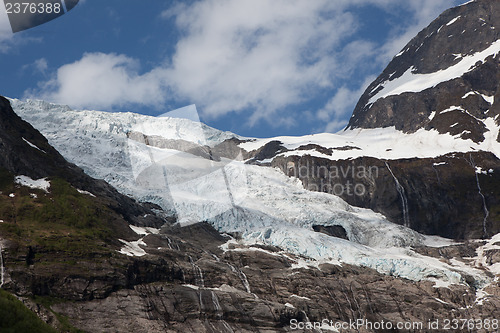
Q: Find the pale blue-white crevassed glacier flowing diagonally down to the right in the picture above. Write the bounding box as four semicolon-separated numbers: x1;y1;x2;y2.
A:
11;100;491;287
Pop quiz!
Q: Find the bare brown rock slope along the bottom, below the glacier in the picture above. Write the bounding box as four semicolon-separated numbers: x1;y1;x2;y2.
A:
6;220;500;333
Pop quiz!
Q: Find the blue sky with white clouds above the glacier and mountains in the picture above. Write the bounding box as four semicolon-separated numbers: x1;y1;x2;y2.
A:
0;0;466;137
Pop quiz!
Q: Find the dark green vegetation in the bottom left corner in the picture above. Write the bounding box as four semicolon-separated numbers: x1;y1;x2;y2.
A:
0;289;57;333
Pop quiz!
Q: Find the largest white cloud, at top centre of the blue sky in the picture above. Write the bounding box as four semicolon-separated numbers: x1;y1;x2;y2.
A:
163;0;356;123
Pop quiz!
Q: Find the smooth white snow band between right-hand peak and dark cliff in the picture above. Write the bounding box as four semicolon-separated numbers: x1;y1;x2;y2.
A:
239;119;500;160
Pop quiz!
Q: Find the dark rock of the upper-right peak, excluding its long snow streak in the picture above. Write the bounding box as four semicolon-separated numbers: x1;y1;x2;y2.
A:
348;0;500;142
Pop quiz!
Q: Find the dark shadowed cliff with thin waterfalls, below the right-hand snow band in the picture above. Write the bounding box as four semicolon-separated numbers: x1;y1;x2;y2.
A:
271;152;500;239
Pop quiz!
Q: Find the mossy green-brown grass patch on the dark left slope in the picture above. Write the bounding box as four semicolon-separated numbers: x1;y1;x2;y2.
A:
0;170;117;257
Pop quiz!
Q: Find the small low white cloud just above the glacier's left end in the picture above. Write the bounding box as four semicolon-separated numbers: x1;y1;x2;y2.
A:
26;53;165;109
